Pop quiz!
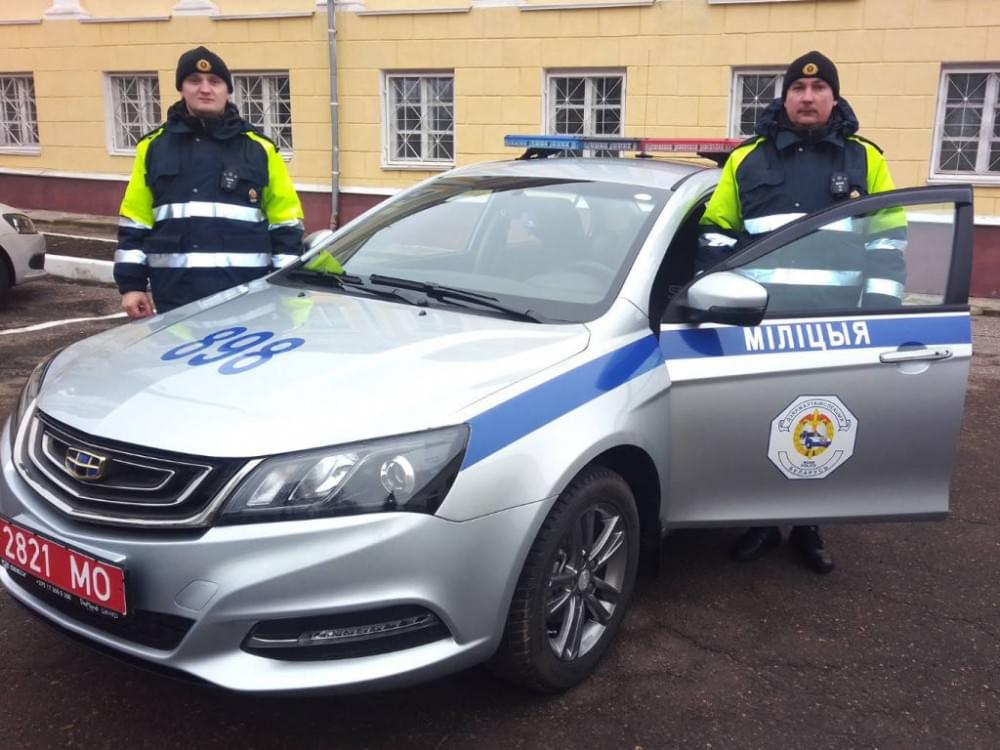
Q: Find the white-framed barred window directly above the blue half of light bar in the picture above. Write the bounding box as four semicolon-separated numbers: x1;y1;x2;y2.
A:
545;73;625;144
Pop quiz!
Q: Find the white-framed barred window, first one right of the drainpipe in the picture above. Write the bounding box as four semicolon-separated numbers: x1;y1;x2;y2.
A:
383;73;455;166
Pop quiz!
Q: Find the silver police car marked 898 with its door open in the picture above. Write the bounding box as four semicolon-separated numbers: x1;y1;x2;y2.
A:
0;138;973;692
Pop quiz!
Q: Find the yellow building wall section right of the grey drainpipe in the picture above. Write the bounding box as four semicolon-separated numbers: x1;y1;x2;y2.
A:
337;0;1000;206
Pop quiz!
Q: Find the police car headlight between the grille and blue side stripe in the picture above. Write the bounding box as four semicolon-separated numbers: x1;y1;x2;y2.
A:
220;425;469;524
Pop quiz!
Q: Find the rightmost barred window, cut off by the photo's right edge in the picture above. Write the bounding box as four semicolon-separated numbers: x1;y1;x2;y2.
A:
932;68;1000;182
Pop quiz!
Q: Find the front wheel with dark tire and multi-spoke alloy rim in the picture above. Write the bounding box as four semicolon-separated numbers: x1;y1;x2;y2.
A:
488;467;639;693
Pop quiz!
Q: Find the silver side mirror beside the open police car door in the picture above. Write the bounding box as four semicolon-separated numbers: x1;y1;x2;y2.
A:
678;271;767;326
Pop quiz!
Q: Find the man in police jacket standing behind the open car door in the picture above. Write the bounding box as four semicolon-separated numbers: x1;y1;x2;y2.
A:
696;51;906;573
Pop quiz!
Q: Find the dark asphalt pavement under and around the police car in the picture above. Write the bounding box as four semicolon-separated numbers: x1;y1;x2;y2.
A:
0;278;1000;750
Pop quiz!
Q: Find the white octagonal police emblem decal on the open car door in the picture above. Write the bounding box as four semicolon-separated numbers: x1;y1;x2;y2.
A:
767;396;858;479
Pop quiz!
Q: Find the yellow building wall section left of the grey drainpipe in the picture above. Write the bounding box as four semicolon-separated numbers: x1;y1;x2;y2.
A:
0;10;330;184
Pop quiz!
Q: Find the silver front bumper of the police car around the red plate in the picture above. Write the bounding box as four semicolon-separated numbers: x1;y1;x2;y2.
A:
0;420;549;692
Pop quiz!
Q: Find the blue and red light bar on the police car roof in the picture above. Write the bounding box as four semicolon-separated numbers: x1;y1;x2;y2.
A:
503;135;742;164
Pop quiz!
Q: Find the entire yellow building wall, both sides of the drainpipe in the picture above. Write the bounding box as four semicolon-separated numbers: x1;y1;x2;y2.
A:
0;0;1000;215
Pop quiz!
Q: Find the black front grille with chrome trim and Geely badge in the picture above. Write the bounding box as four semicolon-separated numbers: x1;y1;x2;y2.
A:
20;412;246;527
